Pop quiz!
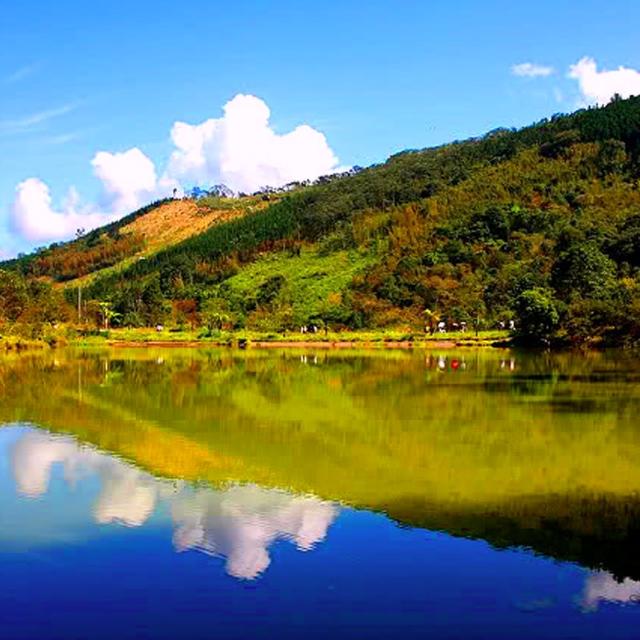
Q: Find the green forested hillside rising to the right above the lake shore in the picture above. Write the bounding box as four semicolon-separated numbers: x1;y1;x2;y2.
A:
0;97;640;344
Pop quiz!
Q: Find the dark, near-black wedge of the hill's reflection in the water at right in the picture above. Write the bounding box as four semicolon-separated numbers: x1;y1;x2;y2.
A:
377;489;640;581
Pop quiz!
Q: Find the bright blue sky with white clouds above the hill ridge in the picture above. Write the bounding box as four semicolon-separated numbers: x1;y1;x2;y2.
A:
0;0;640;254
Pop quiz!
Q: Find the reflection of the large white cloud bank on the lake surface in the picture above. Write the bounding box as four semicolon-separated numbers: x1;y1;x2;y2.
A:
12;431;338;579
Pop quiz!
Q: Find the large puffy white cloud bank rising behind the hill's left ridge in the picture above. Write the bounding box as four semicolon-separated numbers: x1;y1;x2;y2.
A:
6;94;339;250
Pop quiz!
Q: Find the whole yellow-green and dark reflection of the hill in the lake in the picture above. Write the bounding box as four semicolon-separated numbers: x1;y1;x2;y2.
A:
0;351;640;577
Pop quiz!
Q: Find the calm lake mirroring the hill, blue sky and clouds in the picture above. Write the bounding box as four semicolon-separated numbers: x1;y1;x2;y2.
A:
0;349;640;640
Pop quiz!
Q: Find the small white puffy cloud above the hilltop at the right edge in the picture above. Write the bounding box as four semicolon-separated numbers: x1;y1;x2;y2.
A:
569;57;640;104
